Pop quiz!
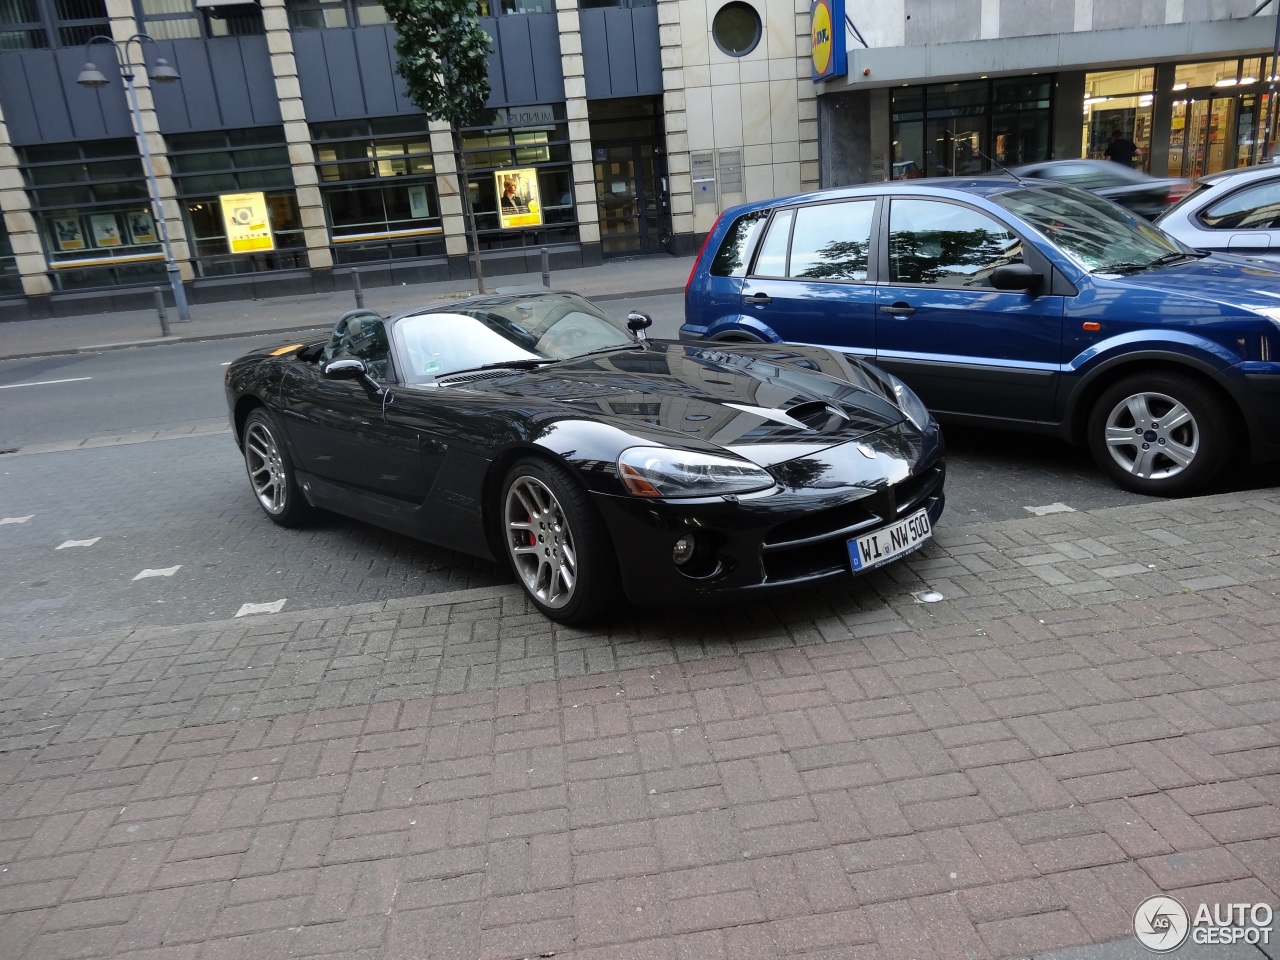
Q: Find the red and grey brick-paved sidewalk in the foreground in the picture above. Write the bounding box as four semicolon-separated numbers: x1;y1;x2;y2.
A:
0;492;1280;960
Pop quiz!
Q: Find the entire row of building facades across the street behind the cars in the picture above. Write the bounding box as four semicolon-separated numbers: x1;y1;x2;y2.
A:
0;0;1280;319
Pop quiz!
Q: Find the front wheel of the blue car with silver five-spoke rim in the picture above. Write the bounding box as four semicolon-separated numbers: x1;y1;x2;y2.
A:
1088;372;1235;497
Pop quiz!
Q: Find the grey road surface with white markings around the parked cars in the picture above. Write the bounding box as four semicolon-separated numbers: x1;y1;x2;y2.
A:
0;297;1280;655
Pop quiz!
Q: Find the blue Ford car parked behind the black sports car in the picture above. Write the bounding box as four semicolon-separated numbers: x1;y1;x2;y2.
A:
680;175;1280;497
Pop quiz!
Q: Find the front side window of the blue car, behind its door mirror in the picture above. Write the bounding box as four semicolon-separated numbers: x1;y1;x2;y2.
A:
888;200;1023;287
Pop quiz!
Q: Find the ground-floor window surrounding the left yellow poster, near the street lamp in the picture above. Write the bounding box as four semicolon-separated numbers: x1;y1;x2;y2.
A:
166;127;307;276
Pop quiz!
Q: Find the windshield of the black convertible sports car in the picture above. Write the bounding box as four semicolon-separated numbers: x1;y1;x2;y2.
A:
396;293;636;383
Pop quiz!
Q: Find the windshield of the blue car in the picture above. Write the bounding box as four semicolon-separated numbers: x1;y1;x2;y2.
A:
991;186;1194;273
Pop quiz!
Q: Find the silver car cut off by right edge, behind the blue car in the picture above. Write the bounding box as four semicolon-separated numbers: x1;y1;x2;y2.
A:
1156;164;1280;260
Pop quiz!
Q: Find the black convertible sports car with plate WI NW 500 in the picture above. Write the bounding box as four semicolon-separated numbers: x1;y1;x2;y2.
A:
227;292;946;622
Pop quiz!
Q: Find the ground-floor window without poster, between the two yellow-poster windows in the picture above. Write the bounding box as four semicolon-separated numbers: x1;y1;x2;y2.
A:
311;116;444;262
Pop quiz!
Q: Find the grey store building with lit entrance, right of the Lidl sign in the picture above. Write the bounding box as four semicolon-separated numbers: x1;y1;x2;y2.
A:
818;0;1277;186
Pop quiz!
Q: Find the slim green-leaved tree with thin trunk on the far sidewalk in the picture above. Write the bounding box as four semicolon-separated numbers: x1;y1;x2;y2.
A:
381;0;489;293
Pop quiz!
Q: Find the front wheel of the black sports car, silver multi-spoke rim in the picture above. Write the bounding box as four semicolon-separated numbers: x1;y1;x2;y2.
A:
497;457;622;625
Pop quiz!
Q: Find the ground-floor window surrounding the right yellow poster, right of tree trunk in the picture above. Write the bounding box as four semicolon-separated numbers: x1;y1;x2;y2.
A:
461;104;577;250
